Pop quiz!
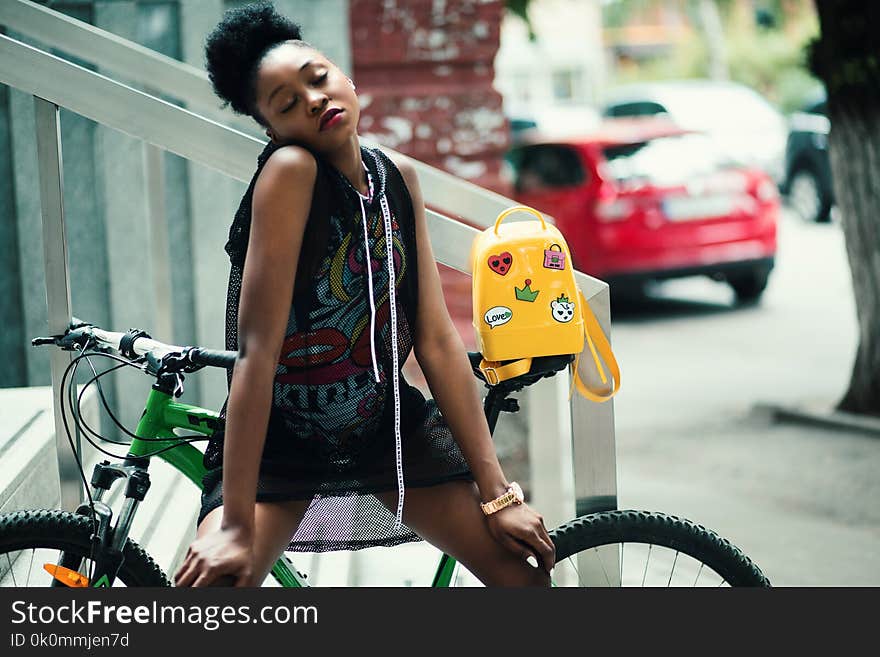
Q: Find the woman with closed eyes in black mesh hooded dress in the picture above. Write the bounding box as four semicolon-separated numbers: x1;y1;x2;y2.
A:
175;3;555;586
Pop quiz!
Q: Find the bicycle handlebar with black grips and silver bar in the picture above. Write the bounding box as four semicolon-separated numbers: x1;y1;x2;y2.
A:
31;317;238;371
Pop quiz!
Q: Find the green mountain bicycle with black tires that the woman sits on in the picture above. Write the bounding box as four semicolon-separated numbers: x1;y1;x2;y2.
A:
0;319;770;587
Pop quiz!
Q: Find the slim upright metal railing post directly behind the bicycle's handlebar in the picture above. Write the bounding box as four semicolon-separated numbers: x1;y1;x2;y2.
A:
34;96;83;511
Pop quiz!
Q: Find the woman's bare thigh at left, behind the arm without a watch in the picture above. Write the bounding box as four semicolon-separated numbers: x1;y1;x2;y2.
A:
197;500;311;586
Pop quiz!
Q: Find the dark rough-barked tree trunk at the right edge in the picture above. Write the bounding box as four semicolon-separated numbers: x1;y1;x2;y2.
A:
809;0;880;416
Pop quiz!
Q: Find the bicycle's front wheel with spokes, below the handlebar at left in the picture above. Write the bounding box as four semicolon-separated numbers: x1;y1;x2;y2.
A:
0;510;171;587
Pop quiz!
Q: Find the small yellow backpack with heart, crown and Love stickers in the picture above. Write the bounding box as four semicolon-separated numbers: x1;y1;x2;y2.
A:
471;205;620;402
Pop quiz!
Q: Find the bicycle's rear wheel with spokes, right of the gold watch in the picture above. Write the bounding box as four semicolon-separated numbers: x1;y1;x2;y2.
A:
550;511;770;587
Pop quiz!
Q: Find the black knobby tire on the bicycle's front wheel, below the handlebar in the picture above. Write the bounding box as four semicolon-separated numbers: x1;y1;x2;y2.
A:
0;509;171;586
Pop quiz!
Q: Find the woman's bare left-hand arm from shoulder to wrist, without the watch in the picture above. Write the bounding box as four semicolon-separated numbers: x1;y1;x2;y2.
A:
221;146;317;535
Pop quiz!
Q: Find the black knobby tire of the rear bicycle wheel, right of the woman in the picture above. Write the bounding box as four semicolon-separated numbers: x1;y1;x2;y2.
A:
549;510;770;587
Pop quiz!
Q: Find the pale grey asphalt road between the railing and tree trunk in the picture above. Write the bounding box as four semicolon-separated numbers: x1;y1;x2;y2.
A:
612;206;880;586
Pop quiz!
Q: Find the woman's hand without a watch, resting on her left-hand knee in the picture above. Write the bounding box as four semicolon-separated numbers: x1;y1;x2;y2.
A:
174;528;257;586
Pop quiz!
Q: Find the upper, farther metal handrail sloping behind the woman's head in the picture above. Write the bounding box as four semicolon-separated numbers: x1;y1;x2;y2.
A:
0;0;528;233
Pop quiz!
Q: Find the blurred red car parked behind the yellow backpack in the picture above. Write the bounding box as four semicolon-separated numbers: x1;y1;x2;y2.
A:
508;119;780;302
